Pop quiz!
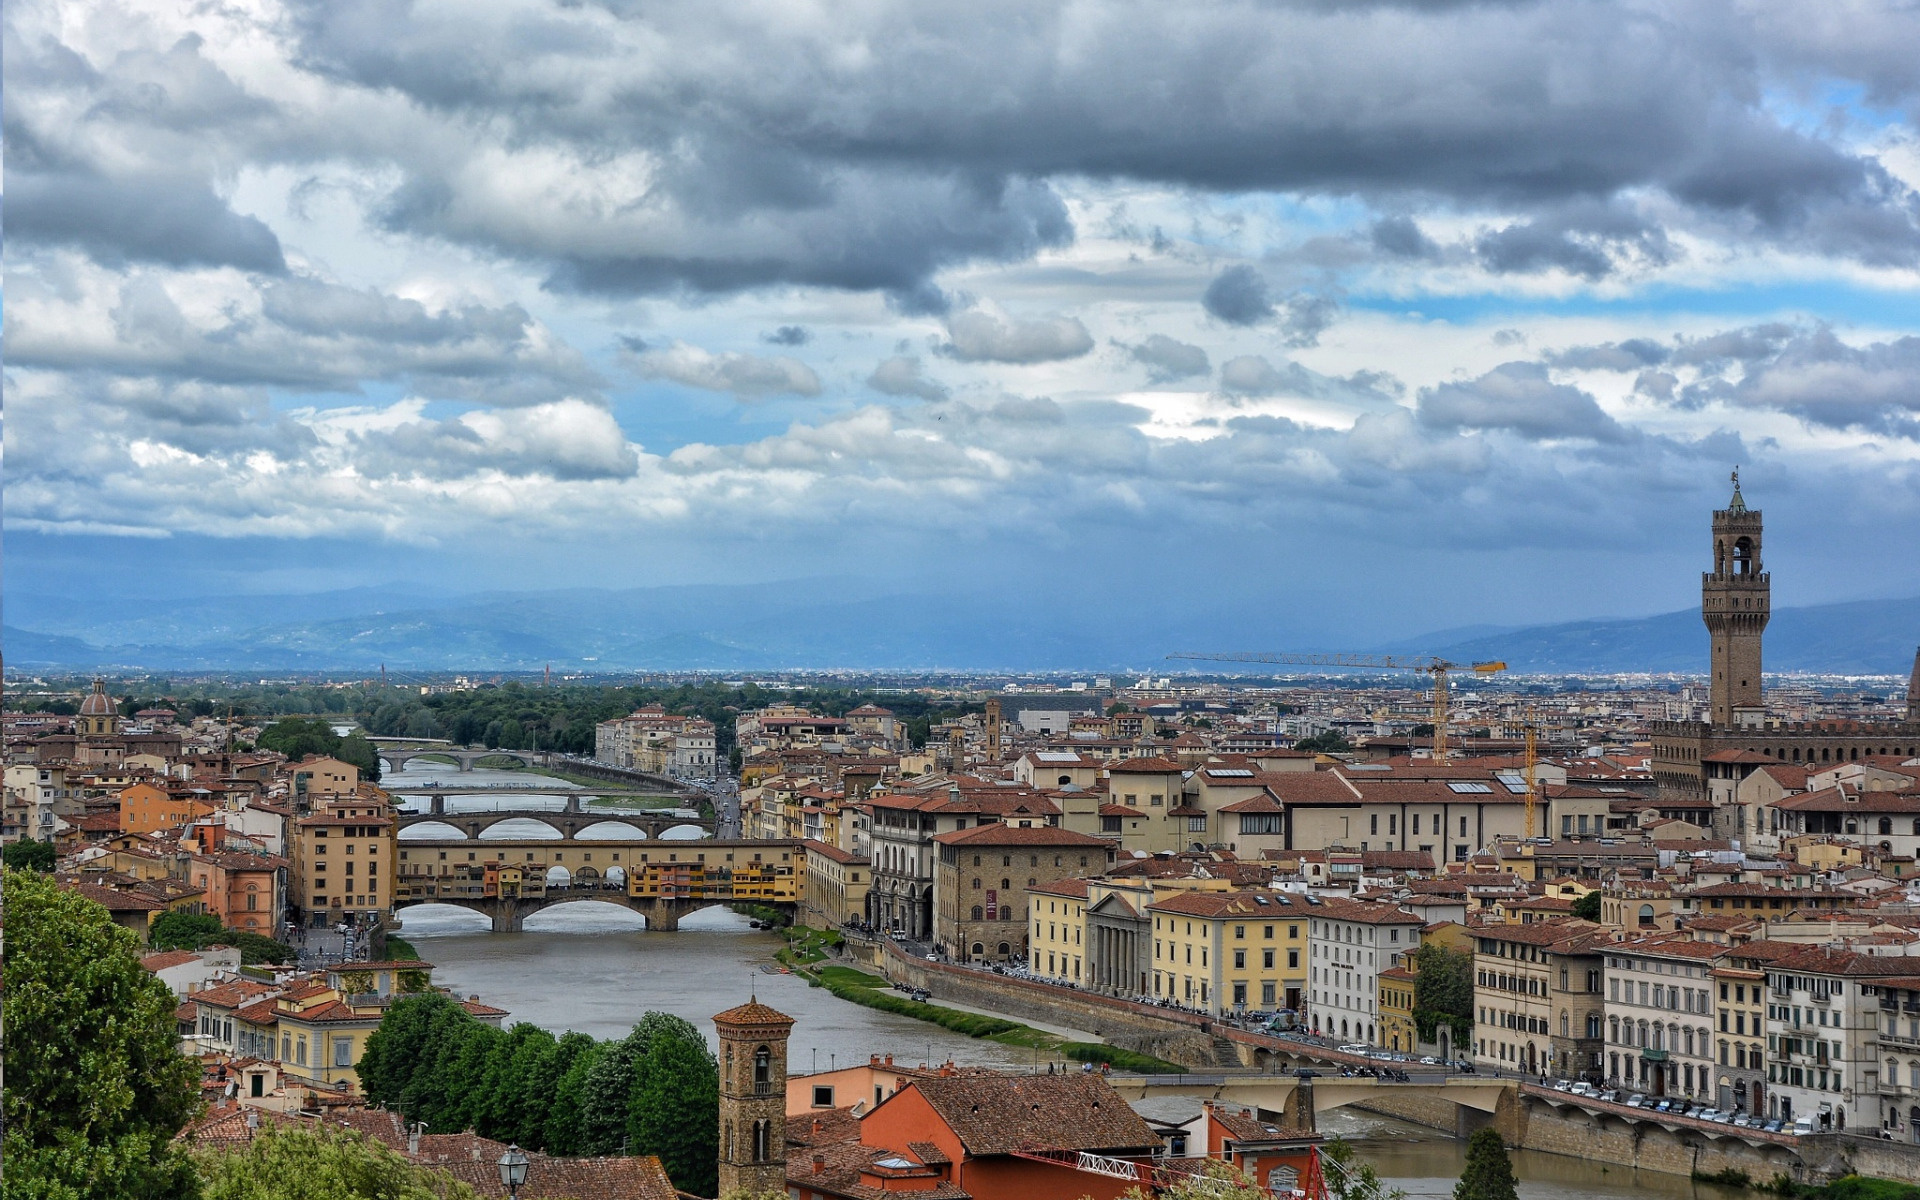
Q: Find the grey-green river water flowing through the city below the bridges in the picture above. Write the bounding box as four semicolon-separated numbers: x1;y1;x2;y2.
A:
386;764;1747;1200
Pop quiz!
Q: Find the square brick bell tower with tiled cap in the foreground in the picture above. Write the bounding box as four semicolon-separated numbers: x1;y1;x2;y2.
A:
714;998;793;1196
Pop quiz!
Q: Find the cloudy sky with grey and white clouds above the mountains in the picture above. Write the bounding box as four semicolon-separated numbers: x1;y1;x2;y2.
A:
6;0;1920;639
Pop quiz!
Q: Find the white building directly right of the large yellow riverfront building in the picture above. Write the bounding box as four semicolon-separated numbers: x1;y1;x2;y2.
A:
1308;897;1427;1044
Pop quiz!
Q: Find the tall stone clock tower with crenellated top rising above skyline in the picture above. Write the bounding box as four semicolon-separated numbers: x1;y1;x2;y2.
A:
1699;470;1770;728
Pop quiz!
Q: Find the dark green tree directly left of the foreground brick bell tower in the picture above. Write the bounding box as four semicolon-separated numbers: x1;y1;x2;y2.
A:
628;1012;720;1196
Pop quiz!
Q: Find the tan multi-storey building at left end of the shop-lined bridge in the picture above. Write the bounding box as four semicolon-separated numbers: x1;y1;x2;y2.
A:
288;787;396;925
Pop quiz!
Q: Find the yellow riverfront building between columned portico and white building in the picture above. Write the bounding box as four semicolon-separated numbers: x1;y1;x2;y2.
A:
1148;889;1311;1014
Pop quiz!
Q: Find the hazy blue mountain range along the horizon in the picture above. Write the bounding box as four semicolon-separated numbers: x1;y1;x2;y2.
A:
0;580;1920;674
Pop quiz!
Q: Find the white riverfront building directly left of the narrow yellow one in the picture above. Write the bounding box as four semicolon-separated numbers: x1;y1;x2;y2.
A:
1607;935;1728;1102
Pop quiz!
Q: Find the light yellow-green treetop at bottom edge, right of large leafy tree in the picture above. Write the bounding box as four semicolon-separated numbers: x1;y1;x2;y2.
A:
196;1123;478;1200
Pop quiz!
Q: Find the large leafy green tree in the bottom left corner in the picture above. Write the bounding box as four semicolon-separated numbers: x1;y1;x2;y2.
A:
4;872;200;1200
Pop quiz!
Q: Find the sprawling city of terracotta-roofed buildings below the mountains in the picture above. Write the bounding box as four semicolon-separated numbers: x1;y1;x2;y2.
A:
4;486;1920;1200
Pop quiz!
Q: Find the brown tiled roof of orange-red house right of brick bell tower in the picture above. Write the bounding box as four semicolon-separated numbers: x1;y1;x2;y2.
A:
889;1073;1162;1158
